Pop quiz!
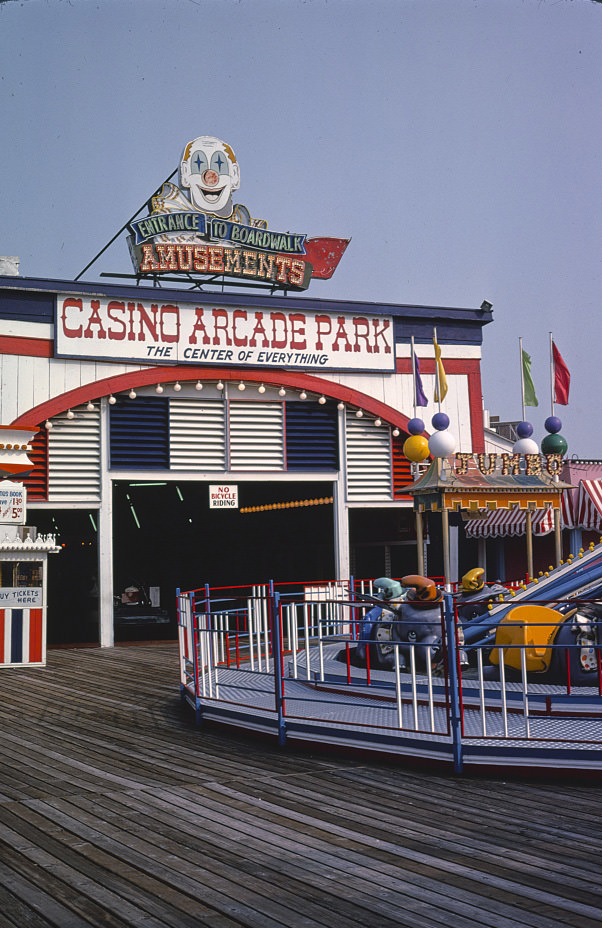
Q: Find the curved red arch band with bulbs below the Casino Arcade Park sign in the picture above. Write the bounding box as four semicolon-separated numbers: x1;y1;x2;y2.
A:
11;367;420;432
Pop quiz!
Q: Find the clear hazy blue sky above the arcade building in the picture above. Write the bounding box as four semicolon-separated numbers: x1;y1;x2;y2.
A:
0;0;602;458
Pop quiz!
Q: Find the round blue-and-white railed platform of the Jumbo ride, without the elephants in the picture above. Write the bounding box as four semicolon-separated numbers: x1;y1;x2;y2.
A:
178;546;602;776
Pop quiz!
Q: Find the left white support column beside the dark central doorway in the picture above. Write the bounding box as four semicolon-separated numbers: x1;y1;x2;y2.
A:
98;396;115;648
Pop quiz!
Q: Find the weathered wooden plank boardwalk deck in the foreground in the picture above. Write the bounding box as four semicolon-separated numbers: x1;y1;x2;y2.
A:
0;643;602;928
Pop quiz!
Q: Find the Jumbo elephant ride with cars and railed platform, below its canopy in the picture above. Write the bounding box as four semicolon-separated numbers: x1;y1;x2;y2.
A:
177;545;602;775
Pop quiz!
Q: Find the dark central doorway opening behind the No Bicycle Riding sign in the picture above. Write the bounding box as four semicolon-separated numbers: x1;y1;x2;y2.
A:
113;479;335;641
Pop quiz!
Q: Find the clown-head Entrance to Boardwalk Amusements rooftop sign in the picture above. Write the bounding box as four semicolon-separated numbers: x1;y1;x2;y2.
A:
128;136;349;290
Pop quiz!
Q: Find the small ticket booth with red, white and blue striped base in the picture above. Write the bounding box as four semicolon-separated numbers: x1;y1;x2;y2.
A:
0;480;60;667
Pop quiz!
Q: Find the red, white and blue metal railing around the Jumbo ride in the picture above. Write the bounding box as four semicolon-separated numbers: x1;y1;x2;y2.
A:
178;583;602;771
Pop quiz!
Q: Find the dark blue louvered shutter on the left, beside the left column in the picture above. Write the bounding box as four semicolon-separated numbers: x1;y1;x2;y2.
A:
109;396;169;470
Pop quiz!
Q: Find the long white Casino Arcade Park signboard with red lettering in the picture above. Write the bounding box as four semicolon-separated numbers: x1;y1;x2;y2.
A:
55;294;395;371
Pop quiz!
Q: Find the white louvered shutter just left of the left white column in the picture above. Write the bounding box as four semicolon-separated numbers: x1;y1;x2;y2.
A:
48;406;100;502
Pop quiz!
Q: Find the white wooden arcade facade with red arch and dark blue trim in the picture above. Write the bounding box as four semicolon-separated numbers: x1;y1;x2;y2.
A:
0;278;488;646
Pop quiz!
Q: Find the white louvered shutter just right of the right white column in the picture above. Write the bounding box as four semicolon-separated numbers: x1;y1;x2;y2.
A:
345;411;392;500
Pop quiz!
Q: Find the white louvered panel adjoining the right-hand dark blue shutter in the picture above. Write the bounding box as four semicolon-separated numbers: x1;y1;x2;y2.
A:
229;401;284;470
